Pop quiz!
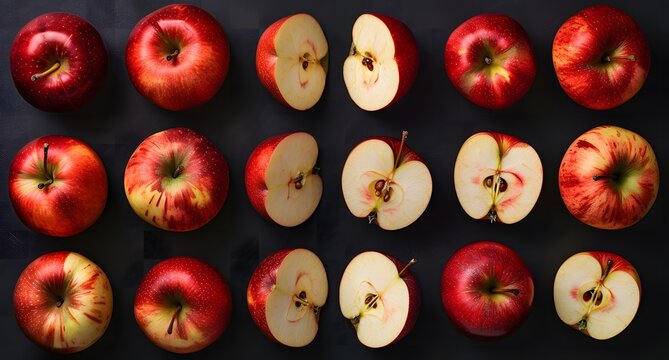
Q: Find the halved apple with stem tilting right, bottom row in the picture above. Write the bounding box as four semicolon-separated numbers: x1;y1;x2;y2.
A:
339;251;420;348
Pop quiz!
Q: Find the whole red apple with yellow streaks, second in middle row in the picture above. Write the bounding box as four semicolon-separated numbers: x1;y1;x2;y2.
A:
123;128;229;231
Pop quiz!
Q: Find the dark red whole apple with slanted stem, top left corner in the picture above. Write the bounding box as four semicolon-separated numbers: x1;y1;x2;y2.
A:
10;13;108;112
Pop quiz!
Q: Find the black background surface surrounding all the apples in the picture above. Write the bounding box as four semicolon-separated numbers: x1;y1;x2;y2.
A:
0;0;669;359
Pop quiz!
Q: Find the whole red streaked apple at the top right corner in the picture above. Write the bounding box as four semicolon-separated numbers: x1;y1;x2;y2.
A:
553;5;650;110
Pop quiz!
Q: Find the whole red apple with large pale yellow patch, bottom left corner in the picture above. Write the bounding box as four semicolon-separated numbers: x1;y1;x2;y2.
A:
14;251;113;353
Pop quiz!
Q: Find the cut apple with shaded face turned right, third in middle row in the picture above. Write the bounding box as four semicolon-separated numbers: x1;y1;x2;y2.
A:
245;132;323;227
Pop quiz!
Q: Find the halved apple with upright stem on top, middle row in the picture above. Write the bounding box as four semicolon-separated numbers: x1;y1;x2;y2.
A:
341;131;432;230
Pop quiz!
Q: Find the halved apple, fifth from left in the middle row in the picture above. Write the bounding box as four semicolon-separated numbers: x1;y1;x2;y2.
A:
453;132;543;224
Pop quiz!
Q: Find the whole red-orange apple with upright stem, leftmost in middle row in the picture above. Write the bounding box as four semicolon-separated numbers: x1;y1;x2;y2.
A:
9;135;108;237
